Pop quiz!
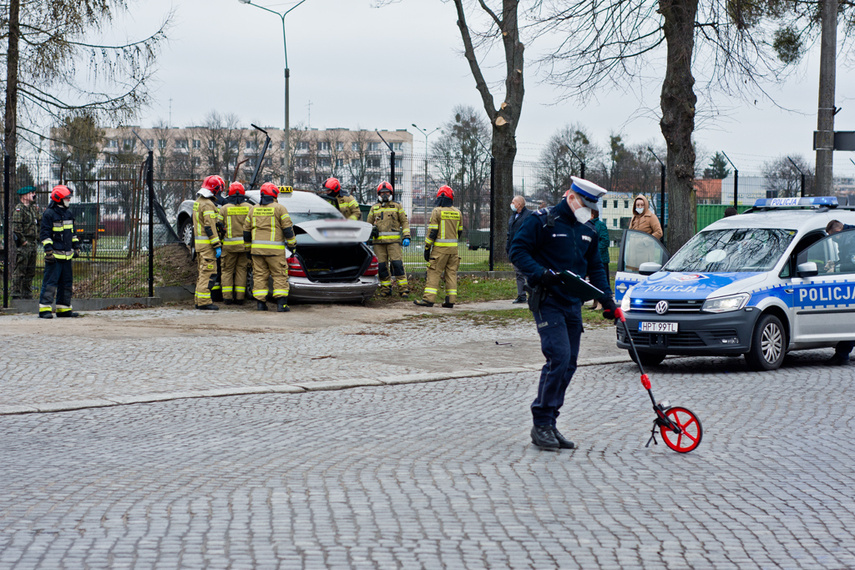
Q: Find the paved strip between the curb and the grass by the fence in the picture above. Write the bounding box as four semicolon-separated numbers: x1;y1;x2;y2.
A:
0;301;627;414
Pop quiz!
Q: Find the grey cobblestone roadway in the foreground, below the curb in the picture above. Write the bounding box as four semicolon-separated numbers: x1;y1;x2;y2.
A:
0;353;855;569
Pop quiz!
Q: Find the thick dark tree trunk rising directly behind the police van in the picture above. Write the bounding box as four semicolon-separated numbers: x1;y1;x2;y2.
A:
659;0;698;252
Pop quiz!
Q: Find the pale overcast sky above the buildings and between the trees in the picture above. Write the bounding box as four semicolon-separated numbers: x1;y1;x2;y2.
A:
108;0;855;176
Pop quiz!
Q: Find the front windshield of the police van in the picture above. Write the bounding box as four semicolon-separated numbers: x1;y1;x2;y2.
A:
663;228;796;273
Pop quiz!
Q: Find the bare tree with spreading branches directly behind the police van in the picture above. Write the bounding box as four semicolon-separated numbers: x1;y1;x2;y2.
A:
543;0;817;249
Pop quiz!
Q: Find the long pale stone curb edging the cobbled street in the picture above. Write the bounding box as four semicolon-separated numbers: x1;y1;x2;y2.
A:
0;356;630;416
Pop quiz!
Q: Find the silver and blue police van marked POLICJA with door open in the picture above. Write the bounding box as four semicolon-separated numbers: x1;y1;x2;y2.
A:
615;197;855;370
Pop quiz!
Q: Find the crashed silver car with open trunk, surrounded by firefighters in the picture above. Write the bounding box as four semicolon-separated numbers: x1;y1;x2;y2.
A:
178;190;380;302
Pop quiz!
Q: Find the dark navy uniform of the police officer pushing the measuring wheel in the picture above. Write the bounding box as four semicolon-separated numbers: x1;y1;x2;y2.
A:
510;199;613;429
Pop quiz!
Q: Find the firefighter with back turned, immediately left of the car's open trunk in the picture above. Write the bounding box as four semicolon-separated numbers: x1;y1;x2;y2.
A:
243;182;297;313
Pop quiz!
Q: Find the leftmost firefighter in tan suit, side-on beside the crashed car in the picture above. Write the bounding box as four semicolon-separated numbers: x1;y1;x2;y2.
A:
193;174;226;311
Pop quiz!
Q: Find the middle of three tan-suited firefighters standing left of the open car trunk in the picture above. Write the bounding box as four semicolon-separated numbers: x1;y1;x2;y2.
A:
220;182;252;305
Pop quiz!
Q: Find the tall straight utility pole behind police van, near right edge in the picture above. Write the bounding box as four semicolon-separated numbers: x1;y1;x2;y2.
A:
813;0;838;196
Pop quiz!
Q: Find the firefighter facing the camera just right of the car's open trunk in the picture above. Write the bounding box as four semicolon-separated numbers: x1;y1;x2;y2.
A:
368;182;410;297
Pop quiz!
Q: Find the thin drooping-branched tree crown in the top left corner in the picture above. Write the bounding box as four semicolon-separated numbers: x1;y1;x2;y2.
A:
0;0;168;178
